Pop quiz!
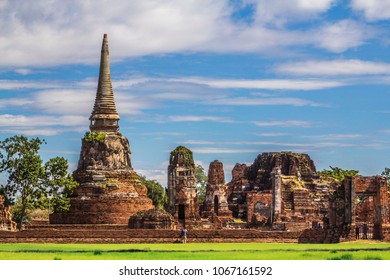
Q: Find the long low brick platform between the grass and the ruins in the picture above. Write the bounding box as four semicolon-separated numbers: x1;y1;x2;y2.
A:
0;225;300;243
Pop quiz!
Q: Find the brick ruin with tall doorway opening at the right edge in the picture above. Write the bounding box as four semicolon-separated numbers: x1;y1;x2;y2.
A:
300;176;390;243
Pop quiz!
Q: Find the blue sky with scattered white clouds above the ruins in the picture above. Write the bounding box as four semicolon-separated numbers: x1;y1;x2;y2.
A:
0;0;390;185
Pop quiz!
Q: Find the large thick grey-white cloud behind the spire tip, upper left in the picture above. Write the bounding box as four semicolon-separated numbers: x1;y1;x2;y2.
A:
0;0;227;66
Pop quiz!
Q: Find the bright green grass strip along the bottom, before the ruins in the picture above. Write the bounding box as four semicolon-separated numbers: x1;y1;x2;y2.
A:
0;241;390;260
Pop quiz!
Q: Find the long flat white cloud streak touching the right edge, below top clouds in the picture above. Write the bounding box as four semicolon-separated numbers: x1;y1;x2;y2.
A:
275;59;390;76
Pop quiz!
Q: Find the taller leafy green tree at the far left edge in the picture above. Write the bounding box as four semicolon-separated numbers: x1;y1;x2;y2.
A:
0;136;44;230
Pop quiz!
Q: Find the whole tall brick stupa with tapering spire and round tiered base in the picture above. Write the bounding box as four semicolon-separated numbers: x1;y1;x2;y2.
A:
50;34;154;224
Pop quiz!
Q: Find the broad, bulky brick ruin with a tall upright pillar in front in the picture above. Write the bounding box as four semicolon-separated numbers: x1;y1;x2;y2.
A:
228;152;336;230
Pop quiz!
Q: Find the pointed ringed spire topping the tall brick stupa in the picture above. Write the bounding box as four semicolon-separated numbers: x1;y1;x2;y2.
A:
89;34;119;133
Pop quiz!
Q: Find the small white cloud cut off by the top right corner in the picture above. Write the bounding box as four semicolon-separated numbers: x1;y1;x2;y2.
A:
351;0;390;21
